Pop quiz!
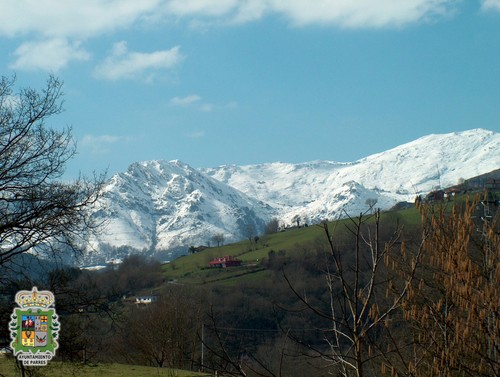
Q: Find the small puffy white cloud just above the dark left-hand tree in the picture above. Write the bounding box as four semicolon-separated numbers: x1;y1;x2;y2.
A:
10;38;90;72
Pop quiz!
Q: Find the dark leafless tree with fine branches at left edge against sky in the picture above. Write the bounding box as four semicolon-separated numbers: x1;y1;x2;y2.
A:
0;76;104;265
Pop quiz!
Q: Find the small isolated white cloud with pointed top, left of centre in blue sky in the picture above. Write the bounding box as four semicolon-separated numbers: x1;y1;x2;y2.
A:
95;41;183;80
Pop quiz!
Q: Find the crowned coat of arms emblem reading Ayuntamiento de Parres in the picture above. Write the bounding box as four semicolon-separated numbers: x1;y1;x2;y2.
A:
9;287;59;366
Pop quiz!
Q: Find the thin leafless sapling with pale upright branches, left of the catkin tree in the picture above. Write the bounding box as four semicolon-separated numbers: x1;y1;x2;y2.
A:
284;211;428;377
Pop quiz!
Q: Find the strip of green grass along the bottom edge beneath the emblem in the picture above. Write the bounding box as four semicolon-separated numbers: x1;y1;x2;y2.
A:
0;358;210;377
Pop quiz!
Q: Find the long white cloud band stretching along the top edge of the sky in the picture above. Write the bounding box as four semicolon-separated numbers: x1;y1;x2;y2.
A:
0;0;460;40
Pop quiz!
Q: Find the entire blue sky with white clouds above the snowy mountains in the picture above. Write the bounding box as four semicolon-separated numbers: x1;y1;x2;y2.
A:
0;0;500;176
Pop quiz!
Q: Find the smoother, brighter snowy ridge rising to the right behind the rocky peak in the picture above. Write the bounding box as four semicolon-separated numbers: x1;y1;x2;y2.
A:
203;129;500;222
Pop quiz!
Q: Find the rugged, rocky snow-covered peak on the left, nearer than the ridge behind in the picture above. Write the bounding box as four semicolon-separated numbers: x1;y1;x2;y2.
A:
87;161;272;262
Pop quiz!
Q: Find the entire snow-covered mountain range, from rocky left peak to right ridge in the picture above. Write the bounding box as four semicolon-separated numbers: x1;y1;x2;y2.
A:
84;129;500;259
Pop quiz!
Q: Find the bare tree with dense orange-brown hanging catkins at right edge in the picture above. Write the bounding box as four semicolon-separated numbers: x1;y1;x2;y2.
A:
404;195;500;377
